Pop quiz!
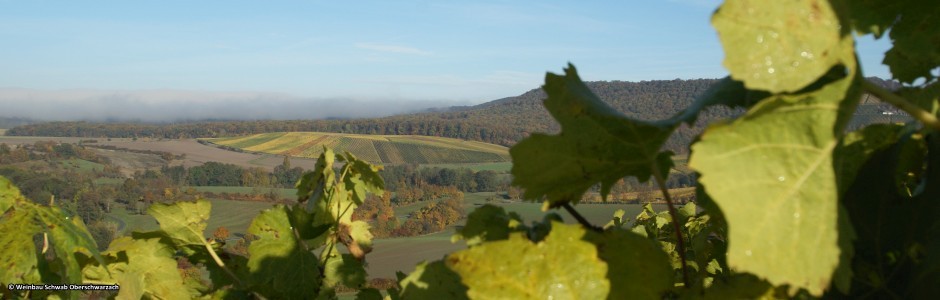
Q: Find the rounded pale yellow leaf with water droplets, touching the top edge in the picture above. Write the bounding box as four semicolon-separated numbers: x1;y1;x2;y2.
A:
712;0;854;92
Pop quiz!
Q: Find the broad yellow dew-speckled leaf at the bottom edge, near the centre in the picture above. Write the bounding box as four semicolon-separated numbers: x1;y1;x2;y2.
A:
446;223;610;299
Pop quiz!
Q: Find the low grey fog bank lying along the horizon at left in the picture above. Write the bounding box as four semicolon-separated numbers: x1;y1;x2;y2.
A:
0;89;466;122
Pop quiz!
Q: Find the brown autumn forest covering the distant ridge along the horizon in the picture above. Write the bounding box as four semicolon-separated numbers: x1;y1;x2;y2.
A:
6;78;900;153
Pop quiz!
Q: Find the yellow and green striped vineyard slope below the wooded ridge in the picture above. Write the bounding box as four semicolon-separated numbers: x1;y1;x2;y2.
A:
205;132;509;164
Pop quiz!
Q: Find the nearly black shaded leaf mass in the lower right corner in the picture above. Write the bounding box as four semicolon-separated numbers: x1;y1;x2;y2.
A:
843;134;940;299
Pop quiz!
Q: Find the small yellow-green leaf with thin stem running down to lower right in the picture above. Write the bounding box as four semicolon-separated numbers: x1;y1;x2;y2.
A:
147;200;212;246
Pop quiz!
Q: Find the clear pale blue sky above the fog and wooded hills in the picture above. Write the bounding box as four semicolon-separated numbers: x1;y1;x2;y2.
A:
0;0;888;103
